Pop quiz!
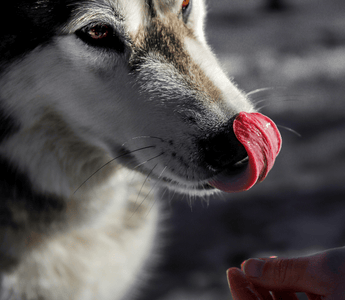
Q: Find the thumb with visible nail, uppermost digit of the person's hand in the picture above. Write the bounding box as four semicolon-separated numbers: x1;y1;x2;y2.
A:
242;253;338;295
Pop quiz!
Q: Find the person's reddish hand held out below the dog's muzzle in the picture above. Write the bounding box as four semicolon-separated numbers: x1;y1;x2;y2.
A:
227;247;345;300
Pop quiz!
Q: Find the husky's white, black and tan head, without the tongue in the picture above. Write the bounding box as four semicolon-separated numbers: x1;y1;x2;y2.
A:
1;0;278;193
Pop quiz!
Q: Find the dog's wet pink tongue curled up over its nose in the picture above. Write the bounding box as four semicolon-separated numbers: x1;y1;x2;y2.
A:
209;112;282;192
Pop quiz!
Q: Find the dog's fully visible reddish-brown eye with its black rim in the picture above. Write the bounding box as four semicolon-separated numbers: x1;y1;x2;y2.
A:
76;24;126;53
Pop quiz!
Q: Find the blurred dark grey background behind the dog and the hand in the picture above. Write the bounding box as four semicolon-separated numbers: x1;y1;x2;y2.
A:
141;0;345;300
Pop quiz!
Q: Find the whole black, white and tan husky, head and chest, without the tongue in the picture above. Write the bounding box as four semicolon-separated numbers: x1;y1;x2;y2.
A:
0;0;254;300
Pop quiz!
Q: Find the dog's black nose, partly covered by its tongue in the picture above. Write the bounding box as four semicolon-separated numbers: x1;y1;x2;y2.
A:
200;116;247;171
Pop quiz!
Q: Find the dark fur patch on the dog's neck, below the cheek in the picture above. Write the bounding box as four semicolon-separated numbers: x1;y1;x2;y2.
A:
0;156;66;271
